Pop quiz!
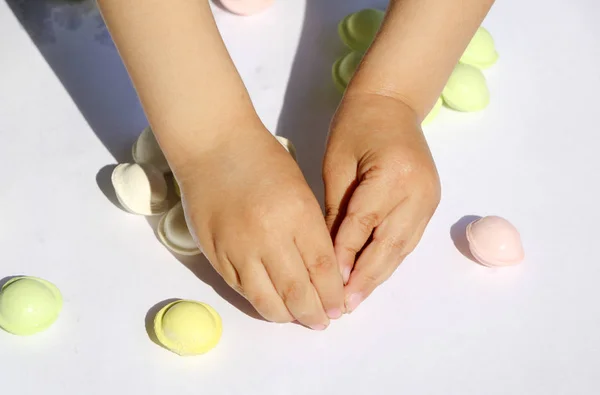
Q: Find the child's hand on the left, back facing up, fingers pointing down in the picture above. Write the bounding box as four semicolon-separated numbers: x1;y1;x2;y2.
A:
176;128;344;329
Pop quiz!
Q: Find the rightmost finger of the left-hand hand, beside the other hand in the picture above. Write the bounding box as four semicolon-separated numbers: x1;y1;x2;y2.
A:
296;221;345;319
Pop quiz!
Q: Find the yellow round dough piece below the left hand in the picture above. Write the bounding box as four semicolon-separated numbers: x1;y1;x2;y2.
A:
154;300;223;356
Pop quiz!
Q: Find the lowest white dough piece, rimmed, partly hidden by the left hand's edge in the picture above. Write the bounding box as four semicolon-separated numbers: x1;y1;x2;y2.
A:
157;202;200;256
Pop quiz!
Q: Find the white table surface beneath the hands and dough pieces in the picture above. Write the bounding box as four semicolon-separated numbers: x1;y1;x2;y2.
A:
0;0;600;395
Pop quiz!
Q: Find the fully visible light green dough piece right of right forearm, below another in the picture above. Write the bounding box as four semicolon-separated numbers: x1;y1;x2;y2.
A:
442;63;490;112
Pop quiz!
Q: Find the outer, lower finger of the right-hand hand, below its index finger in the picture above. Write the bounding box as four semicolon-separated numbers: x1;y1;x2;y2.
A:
345;204;428;312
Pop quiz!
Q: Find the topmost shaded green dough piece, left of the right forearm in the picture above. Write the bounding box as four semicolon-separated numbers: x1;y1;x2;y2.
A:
338;8;385;52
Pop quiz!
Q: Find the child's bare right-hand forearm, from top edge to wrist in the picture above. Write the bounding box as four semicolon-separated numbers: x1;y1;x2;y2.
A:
348;0;494;119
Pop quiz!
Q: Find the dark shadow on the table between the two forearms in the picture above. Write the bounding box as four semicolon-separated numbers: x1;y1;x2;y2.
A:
276;0;388;205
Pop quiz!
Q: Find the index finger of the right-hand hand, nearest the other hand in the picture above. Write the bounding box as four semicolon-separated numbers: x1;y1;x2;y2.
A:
334;178;402;283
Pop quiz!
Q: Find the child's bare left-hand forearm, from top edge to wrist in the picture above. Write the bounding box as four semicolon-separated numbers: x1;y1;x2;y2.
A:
98;0;259;166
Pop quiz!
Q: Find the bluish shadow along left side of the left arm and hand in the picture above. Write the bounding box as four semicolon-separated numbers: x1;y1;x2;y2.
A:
5;0;259;318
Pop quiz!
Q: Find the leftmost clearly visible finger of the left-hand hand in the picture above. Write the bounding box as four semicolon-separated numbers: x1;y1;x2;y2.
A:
237;260;294;323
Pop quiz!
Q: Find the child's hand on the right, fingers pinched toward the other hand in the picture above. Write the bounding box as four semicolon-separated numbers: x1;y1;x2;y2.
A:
323;94;440;311
